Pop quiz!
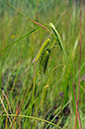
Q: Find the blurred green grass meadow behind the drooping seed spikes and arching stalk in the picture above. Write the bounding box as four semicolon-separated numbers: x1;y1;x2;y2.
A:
0;0;85;129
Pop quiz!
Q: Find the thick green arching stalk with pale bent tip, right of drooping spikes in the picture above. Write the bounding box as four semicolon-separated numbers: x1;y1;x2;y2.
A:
50;23;81;129
